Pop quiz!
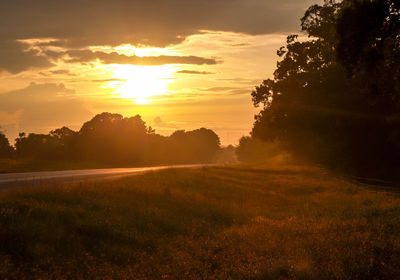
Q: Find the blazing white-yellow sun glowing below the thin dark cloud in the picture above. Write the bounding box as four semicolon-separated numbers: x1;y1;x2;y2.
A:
110;65;175;104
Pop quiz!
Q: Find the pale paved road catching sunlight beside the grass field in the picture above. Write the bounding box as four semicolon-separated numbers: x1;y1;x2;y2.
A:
0;164;205;191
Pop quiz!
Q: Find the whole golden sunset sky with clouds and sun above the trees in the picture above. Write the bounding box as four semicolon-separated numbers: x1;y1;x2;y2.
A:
0;0;319;145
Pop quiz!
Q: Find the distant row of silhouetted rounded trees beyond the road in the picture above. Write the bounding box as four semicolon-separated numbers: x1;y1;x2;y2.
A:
0;113;220;166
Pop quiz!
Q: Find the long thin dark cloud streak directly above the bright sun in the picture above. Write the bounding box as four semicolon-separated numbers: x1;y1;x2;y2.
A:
66;50;218;65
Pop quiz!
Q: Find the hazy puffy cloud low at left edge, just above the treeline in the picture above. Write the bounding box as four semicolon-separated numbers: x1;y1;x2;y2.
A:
0;83;92;139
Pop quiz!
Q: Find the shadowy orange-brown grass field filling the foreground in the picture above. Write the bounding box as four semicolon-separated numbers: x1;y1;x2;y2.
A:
0;165;400;279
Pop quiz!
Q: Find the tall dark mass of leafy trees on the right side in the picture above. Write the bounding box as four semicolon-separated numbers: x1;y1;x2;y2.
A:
252;0;400;179
